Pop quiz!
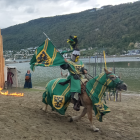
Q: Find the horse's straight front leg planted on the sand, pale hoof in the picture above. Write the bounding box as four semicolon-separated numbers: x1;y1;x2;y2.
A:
87;106;99;132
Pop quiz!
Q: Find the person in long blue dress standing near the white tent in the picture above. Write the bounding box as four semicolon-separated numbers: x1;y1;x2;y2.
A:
24;70;32;88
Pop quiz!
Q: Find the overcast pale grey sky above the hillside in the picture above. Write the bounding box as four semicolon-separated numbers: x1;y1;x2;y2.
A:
0;0;136;29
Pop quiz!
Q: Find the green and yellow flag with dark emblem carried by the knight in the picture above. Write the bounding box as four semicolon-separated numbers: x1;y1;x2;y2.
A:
30;39;65;70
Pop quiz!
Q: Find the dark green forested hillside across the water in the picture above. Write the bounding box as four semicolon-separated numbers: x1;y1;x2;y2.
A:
2;2;140;54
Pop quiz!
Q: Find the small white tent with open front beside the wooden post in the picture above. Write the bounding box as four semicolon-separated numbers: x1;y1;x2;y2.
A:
4;66;18;87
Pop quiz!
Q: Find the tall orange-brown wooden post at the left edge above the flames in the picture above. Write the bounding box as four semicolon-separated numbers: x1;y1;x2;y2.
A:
0;29;5;88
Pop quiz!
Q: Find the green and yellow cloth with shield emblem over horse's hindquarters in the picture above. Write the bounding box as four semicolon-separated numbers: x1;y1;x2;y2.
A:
42;78;71;115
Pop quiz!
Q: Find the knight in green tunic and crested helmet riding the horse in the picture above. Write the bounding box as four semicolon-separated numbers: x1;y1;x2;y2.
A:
59;36;87;111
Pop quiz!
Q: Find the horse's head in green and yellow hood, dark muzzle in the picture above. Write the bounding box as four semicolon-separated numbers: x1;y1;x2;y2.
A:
104;69;127;91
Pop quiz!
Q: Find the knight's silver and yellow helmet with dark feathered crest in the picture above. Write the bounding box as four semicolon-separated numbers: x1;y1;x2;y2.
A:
67;36;80;62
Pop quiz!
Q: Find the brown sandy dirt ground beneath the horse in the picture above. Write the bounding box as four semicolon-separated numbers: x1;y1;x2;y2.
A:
0;89;140;140
